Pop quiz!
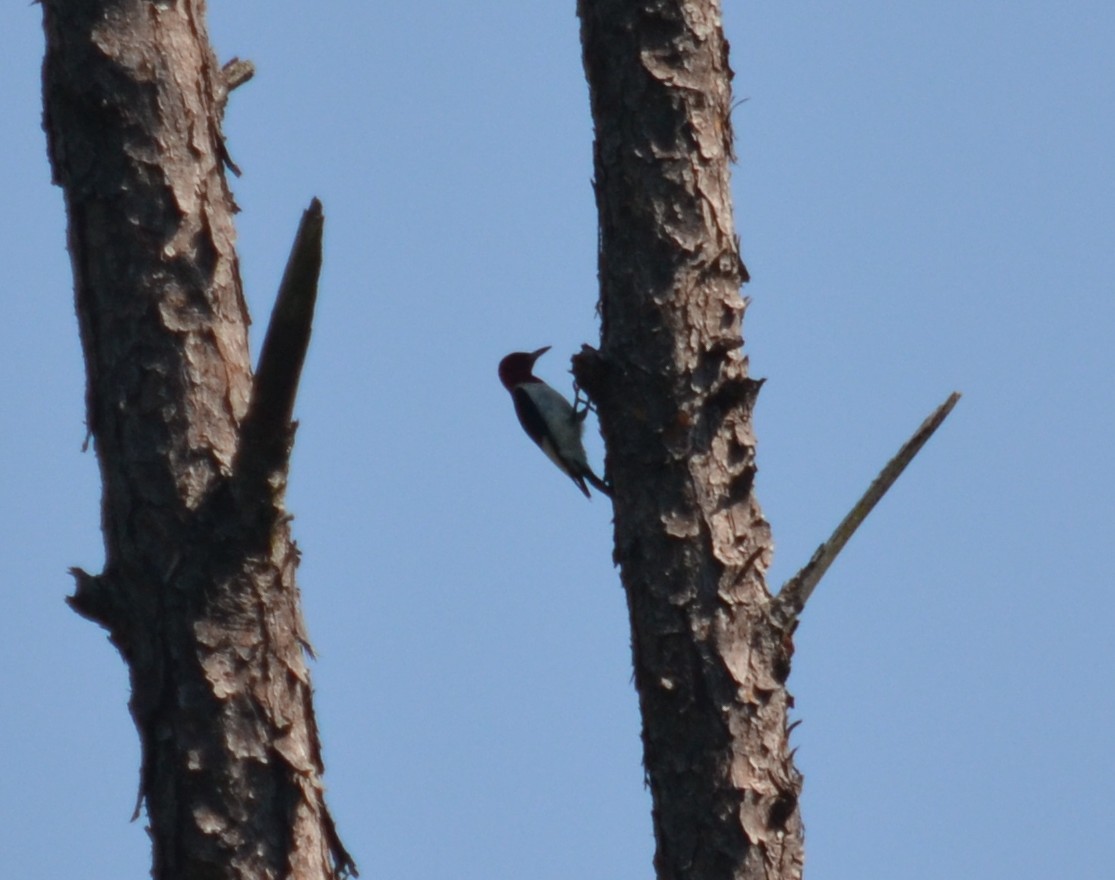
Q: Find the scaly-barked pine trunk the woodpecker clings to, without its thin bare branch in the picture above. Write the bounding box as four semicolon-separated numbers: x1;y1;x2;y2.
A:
574;0;802;880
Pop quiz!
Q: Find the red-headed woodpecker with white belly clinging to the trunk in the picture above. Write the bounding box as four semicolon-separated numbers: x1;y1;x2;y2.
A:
500;346;612;497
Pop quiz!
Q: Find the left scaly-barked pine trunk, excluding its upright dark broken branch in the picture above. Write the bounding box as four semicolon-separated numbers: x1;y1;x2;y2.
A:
43;0;352;880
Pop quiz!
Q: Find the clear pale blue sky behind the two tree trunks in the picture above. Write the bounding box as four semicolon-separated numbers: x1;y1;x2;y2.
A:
0;0;1115;880
